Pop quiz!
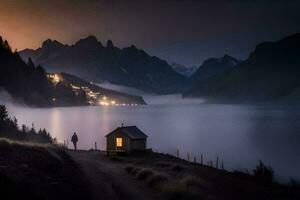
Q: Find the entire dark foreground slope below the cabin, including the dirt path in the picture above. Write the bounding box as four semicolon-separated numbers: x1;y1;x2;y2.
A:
0;139;300;200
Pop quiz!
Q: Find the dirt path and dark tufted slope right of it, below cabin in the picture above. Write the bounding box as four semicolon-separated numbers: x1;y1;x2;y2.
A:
70;151;300;200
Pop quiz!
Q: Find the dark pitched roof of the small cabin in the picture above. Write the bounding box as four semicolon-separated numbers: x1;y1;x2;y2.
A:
105;126;148;139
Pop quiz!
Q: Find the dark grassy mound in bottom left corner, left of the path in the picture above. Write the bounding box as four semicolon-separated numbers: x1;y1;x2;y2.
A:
0;139;90;200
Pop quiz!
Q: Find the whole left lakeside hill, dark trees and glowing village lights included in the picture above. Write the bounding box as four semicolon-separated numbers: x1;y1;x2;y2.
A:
0;37;146;107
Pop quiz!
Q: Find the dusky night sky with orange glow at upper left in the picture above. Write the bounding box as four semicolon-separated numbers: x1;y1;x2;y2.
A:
0;0;300;66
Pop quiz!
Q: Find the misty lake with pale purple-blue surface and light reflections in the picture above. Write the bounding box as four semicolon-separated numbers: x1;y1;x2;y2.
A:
4;101;300;181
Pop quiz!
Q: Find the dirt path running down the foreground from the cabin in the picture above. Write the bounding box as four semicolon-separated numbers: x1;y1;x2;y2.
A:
69;151;152;200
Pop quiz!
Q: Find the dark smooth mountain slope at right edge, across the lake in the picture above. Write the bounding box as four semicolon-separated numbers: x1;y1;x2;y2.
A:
183;34;300;103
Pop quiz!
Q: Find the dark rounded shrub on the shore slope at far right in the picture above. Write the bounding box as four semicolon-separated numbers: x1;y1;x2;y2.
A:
253;160;274;183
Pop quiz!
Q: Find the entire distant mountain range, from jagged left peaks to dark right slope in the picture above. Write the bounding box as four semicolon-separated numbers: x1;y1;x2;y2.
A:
20;34;300;103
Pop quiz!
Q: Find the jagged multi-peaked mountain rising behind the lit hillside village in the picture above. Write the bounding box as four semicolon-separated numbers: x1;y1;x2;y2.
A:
19;36;188;94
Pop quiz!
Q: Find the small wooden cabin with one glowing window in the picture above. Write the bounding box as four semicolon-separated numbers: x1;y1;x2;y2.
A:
105;126;148;154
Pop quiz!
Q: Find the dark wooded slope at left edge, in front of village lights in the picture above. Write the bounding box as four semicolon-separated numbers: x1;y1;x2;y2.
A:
0;37;86;106
